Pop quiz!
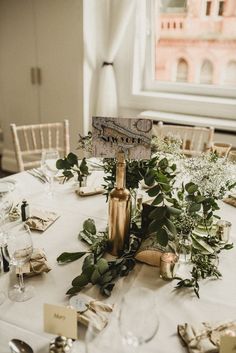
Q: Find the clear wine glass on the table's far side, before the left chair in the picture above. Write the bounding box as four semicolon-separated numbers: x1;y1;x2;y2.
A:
41;149;60;196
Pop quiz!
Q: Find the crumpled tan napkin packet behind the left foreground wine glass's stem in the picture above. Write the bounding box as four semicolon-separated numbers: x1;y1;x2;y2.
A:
16;249;51;277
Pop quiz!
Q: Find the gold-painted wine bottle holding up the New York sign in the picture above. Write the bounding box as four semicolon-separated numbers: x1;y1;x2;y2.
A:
109;152;131;256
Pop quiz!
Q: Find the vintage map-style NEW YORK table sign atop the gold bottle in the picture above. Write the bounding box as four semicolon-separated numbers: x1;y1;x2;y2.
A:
92;117;152;159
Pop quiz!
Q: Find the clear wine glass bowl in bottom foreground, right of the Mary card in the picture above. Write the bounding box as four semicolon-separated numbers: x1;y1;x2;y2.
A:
118;287;159;351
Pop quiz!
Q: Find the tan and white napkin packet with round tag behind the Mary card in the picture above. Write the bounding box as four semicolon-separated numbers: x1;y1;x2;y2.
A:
70;293;113;331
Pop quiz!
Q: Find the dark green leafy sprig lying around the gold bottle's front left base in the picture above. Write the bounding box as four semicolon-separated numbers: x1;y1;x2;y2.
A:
57;219;140;296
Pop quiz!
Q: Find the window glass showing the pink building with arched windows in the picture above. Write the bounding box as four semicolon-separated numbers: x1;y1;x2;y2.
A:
155;0;236;86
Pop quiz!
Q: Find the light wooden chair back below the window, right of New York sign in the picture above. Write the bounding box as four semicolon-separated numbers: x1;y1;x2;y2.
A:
153;121;214;156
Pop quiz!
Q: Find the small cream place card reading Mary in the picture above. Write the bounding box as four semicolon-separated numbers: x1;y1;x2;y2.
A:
44;304;77;339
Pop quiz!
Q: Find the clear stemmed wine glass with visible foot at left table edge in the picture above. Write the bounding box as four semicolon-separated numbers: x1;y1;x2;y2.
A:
4;224;34;302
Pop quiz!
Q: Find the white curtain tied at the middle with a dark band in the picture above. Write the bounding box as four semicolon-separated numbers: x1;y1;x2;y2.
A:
96;0;136;117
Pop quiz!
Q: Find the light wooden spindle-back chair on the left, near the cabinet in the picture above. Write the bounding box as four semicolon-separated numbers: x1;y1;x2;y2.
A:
10;120;70;172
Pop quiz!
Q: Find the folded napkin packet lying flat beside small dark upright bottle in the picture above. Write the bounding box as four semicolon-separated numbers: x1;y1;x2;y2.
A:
25;209;59;232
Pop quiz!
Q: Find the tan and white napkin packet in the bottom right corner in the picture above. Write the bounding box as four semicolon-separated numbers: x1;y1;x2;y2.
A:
177;321;236;353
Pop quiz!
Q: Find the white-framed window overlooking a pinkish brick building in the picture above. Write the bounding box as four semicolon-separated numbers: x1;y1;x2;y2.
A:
126;0;236;119
